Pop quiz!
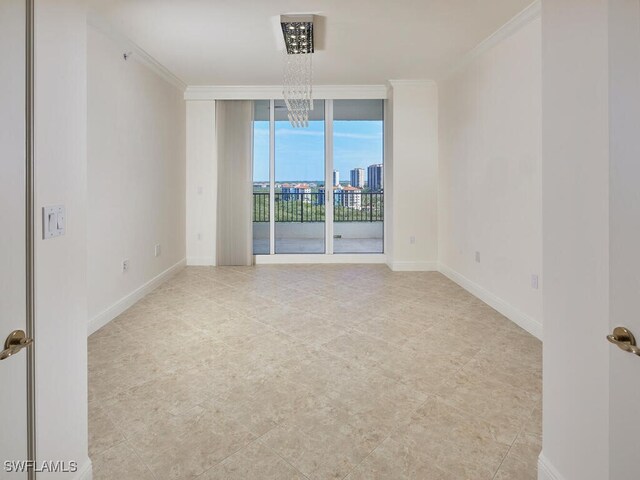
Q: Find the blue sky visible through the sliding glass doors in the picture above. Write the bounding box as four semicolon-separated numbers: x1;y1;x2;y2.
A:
253;120;383;182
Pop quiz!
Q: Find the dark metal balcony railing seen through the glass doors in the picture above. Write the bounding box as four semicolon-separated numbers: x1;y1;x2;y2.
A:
253;192;384;223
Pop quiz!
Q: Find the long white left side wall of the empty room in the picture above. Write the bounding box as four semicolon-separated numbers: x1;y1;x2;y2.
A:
87;25;186;331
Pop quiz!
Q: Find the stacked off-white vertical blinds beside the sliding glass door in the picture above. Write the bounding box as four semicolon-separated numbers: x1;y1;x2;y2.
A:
216;100;253;266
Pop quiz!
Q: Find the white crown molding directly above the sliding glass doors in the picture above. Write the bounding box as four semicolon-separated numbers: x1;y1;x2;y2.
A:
184;85;387;100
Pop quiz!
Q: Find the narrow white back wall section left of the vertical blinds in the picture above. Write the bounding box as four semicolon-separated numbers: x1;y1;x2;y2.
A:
186;100;218;265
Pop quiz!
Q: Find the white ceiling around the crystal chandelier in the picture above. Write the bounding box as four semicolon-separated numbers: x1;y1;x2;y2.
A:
92;0;532;85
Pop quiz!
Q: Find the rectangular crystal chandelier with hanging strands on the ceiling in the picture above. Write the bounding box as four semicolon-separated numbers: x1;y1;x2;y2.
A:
280;15;313;127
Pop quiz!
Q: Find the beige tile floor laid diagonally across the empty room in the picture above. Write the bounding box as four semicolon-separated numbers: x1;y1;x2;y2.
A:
89;265;542;480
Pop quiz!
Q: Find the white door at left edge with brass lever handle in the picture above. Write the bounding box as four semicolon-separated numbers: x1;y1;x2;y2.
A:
0;0;28;480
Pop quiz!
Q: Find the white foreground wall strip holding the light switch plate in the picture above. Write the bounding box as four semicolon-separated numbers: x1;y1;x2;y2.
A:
34;0;91;479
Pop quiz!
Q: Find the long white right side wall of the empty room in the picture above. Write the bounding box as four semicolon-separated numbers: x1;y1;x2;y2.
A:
438;16;542;336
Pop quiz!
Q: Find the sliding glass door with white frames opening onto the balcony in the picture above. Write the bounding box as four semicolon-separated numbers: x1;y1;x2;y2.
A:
253;100;384;255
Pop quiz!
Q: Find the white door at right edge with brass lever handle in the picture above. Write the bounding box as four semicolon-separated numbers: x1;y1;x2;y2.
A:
608;0;640;480
